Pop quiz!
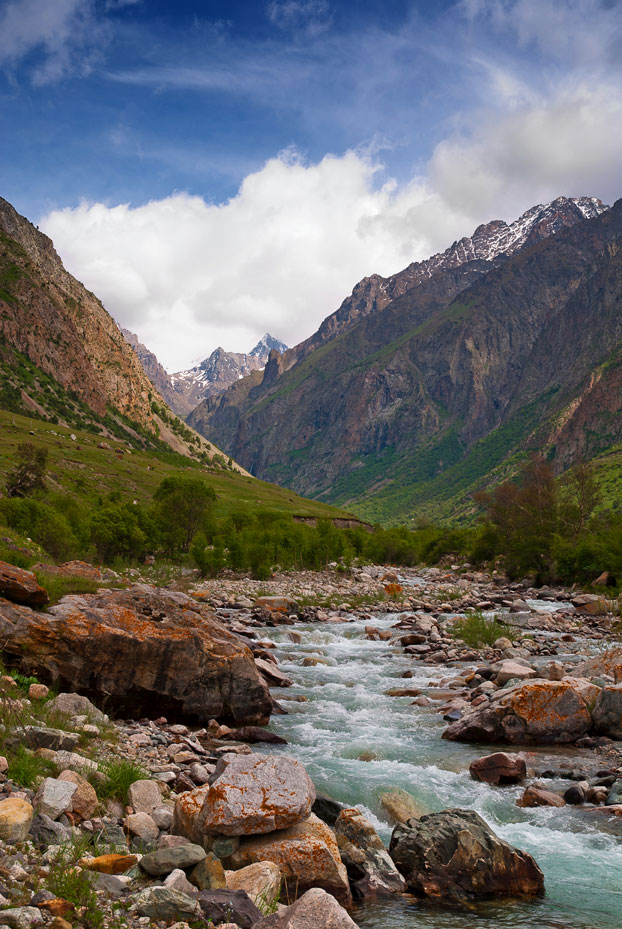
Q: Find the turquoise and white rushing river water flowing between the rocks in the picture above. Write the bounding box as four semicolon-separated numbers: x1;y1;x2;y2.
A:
260;615;622;929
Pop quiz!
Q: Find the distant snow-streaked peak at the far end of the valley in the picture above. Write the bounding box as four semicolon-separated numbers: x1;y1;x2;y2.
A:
167;332;287;416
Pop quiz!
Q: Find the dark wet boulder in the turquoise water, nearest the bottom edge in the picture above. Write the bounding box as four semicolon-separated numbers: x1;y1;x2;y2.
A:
389;810;544;901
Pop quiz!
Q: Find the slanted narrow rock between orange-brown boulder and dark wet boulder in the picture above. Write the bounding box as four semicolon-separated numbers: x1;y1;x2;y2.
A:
335;808;406;899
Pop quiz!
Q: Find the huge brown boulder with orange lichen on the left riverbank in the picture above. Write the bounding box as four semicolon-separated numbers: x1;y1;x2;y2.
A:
0;584;272;723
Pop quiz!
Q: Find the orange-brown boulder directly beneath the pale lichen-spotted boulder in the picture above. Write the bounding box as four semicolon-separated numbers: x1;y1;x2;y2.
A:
226;813;352;906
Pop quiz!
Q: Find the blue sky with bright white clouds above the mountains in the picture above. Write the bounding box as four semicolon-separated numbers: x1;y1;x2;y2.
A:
0;0;622;371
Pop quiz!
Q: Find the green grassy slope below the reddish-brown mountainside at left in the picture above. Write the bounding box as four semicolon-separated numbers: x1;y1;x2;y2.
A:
0;410;358;518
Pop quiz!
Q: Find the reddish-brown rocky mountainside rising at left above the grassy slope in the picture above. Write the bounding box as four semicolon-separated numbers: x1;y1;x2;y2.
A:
0;198;232;461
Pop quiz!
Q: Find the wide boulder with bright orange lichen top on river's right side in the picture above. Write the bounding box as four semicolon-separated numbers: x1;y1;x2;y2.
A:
443;678;592;745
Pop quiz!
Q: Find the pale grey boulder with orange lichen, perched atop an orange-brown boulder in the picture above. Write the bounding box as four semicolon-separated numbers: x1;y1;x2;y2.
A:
175;753;315;841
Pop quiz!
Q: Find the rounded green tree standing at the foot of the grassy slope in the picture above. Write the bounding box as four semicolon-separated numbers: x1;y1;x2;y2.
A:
153;474;216;552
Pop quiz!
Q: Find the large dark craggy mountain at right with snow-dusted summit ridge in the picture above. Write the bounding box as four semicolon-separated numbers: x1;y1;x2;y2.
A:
189;198;622;521
